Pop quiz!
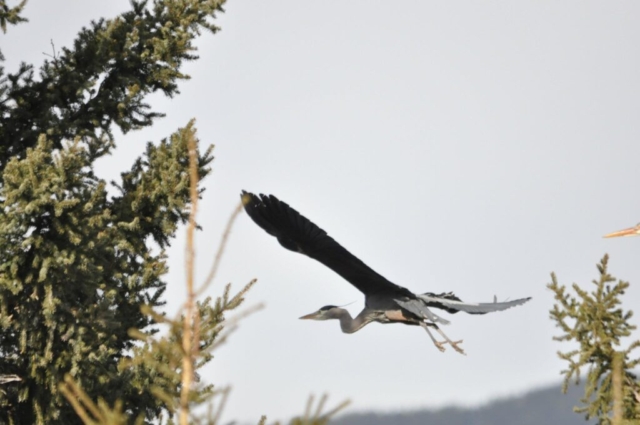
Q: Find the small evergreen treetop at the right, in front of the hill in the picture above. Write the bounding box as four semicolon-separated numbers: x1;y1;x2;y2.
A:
548;255;640;425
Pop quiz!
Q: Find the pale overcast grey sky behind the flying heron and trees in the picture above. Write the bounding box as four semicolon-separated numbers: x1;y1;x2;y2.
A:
2;0;640;422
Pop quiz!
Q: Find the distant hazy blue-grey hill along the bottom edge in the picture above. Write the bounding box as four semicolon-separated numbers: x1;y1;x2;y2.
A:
331;383;595;425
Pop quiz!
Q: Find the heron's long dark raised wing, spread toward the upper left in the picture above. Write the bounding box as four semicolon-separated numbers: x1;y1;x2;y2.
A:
242;191;415;298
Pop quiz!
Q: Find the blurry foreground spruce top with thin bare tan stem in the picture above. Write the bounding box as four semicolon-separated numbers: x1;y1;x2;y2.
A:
61;120;262;425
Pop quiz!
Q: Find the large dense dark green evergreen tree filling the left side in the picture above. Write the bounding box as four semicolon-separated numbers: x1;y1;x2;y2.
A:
0;0;232;424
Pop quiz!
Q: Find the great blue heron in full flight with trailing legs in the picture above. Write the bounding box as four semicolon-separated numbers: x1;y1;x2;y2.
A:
242;191;531;354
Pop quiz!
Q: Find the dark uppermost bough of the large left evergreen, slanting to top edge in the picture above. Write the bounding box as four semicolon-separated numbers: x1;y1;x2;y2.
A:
0;0;224;170
